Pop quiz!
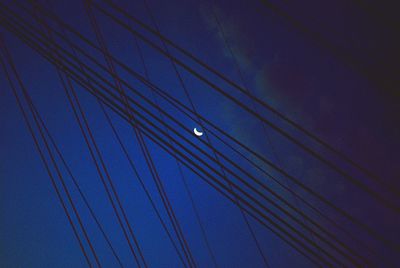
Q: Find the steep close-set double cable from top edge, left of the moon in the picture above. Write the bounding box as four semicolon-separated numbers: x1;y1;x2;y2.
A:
85;1;196;267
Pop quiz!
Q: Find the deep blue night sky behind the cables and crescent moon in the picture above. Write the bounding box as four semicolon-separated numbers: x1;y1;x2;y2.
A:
0;0;400;267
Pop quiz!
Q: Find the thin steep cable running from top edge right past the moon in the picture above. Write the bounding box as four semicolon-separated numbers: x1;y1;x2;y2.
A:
142;0;269;267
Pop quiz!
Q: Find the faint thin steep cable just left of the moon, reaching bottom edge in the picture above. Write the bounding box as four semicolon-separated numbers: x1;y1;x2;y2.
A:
133;15;219;268
